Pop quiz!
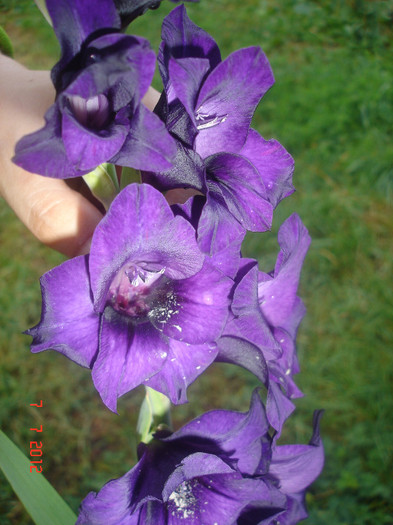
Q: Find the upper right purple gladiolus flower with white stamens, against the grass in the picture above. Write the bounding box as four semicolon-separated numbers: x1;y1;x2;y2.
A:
143;6;293;253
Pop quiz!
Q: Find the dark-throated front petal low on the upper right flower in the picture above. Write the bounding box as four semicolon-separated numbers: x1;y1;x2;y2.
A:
206;153;273;231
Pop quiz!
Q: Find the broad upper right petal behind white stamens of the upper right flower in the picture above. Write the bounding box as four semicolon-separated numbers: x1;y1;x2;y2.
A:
195;47;274;158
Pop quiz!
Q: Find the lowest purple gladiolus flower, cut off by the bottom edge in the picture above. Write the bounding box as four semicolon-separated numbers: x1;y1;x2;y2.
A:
77;392;323;525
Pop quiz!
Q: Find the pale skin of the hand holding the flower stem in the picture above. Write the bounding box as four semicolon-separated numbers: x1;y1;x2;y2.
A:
0;54;159;257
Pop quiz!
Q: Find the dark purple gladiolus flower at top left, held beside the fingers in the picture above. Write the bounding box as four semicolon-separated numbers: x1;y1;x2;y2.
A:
13;0;176;178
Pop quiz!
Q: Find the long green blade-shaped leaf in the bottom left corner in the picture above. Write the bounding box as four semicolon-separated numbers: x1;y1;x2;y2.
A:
0;430;77;525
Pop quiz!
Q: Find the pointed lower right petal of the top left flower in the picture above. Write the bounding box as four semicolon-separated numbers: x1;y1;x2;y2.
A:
111;104;176;171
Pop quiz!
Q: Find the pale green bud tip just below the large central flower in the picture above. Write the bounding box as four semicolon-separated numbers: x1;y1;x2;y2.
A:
137;386;171;443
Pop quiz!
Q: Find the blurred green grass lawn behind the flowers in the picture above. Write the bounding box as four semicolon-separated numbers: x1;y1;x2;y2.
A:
0;0;393;525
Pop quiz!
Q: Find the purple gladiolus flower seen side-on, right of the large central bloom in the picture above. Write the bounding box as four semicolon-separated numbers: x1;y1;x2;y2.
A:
218;214;311;437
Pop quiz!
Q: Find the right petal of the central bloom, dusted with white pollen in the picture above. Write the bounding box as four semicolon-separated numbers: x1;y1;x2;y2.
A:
156;259;233;344
